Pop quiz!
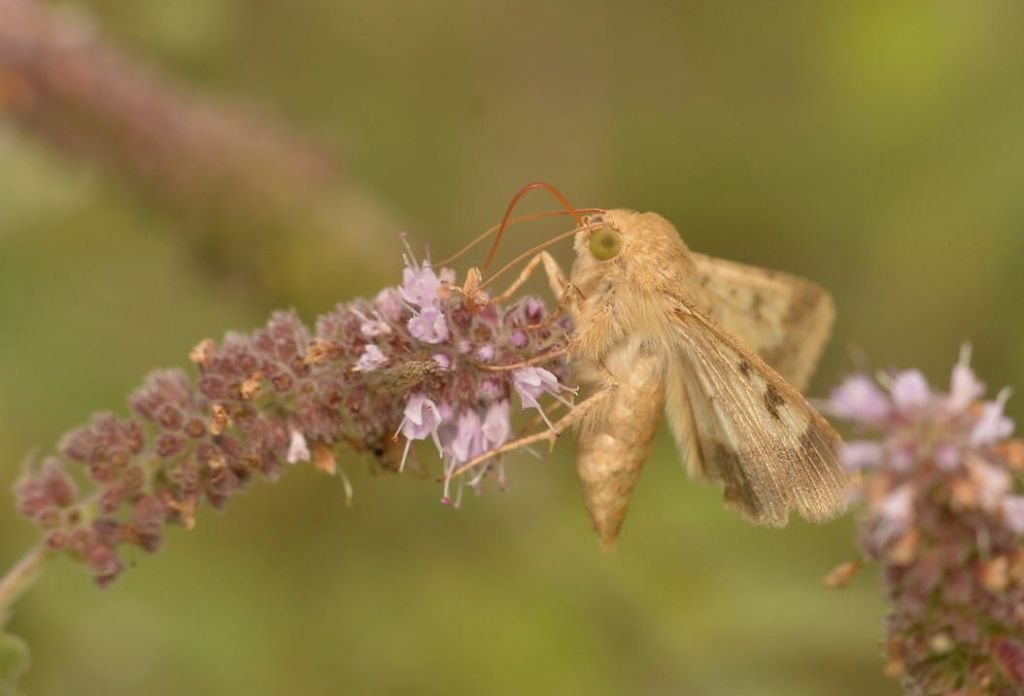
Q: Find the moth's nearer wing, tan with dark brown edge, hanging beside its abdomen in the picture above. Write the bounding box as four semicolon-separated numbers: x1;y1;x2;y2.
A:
666;302;847;526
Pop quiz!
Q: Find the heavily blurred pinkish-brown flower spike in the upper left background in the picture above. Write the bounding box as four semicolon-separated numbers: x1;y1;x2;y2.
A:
0;0;399;304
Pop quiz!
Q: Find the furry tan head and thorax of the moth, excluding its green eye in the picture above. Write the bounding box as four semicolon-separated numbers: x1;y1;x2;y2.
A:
571;210;705;360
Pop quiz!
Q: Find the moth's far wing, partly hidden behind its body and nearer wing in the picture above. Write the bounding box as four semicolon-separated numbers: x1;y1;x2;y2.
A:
692;254;836;390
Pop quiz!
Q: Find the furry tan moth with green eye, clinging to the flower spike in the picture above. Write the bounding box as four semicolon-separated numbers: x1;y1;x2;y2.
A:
452;186;847;547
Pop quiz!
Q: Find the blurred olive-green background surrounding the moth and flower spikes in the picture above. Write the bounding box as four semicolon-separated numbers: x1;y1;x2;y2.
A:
0;0;1024;695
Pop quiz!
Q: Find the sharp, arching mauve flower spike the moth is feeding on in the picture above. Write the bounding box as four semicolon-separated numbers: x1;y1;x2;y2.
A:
16;241;569;584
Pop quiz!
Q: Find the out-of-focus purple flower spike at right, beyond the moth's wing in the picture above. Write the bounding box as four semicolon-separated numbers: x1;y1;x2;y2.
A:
825;351;1024;695
